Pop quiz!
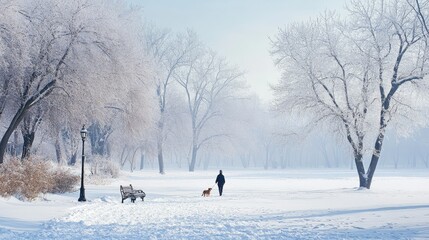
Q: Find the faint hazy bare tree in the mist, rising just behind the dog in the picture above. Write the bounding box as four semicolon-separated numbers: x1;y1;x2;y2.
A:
176;48;242;172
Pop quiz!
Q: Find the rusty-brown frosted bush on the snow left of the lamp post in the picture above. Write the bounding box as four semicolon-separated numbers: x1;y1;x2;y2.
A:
0;158;79;201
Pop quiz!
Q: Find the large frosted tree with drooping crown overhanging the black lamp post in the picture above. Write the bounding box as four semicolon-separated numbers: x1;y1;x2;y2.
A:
0;0;156;163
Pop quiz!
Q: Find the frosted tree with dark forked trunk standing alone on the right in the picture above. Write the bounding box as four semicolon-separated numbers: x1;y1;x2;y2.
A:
272;1;428;188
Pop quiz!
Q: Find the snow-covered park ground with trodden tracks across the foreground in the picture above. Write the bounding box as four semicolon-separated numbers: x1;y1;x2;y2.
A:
0;170;429;239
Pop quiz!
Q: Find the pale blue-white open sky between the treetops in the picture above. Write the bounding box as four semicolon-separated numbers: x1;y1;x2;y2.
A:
135;0;345;101
